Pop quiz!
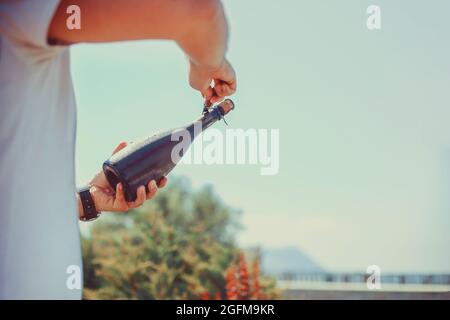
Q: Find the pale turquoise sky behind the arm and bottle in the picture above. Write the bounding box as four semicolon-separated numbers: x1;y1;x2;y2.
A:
71;0;450;272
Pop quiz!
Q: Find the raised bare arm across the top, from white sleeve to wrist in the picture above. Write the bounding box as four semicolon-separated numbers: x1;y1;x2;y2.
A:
48;0;228;68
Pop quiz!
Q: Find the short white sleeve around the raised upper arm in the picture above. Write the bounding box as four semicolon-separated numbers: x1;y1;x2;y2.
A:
0;0;60;49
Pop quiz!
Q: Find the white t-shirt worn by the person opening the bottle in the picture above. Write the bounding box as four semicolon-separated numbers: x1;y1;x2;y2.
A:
0;0;82;299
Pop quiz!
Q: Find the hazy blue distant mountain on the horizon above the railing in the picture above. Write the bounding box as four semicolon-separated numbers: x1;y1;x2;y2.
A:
261;247;325;274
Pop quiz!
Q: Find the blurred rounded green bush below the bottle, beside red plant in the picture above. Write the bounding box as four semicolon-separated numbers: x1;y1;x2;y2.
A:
83;179;278;299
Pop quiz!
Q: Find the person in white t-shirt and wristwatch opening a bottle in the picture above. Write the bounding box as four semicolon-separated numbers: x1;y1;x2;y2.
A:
0;0;236;299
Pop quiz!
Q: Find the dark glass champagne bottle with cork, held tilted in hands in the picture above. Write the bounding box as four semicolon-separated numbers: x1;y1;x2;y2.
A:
103;99;234;201
